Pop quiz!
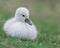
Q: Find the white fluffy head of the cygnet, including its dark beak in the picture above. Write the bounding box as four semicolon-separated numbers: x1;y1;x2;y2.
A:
15;7;32;25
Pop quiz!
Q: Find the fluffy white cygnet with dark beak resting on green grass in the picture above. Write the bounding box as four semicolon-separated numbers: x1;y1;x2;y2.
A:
3;7;37;40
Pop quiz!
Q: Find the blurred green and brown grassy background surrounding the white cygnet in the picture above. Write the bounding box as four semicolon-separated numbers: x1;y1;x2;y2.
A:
0;0;60;48
